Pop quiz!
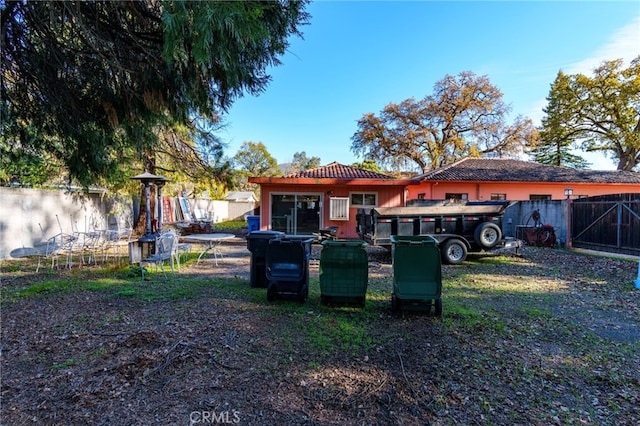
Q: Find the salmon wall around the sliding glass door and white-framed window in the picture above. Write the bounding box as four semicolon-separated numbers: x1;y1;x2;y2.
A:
260;184;405;238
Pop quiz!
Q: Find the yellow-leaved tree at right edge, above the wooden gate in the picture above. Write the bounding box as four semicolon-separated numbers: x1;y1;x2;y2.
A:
540;56;640;171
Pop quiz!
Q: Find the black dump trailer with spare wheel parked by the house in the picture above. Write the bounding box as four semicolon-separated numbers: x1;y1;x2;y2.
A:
357;201;522;265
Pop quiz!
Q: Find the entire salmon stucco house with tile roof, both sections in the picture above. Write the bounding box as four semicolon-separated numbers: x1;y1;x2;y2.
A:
249;158;640;238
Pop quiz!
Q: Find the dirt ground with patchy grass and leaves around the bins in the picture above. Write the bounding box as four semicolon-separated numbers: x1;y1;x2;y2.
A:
0;238;640;425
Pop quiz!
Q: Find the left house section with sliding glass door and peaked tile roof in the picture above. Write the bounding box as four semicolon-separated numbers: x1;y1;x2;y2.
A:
249;162;417;238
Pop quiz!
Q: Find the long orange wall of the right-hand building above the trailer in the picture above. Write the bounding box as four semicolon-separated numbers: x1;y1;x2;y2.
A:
407;182;640;201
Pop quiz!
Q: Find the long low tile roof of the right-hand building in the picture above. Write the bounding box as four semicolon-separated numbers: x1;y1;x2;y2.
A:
414;158;640;185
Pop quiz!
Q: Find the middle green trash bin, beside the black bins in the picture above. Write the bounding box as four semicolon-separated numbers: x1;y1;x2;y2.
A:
319;240;369;307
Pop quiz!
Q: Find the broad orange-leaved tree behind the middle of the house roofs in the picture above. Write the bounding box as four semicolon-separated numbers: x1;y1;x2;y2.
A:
351;71;537;172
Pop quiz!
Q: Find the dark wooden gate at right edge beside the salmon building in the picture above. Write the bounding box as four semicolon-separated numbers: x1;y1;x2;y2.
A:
571;193;640;255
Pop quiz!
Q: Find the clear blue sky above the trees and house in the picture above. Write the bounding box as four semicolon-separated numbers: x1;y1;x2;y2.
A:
219;0;640;169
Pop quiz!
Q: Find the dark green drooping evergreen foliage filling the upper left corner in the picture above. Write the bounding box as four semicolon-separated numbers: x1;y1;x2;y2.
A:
0;0;308;185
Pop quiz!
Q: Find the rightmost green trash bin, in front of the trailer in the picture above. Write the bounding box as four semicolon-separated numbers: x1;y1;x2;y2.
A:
391;235;442;316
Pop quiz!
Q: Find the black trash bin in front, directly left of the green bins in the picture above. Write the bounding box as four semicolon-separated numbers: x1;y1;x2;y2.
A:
265;236;313;303
